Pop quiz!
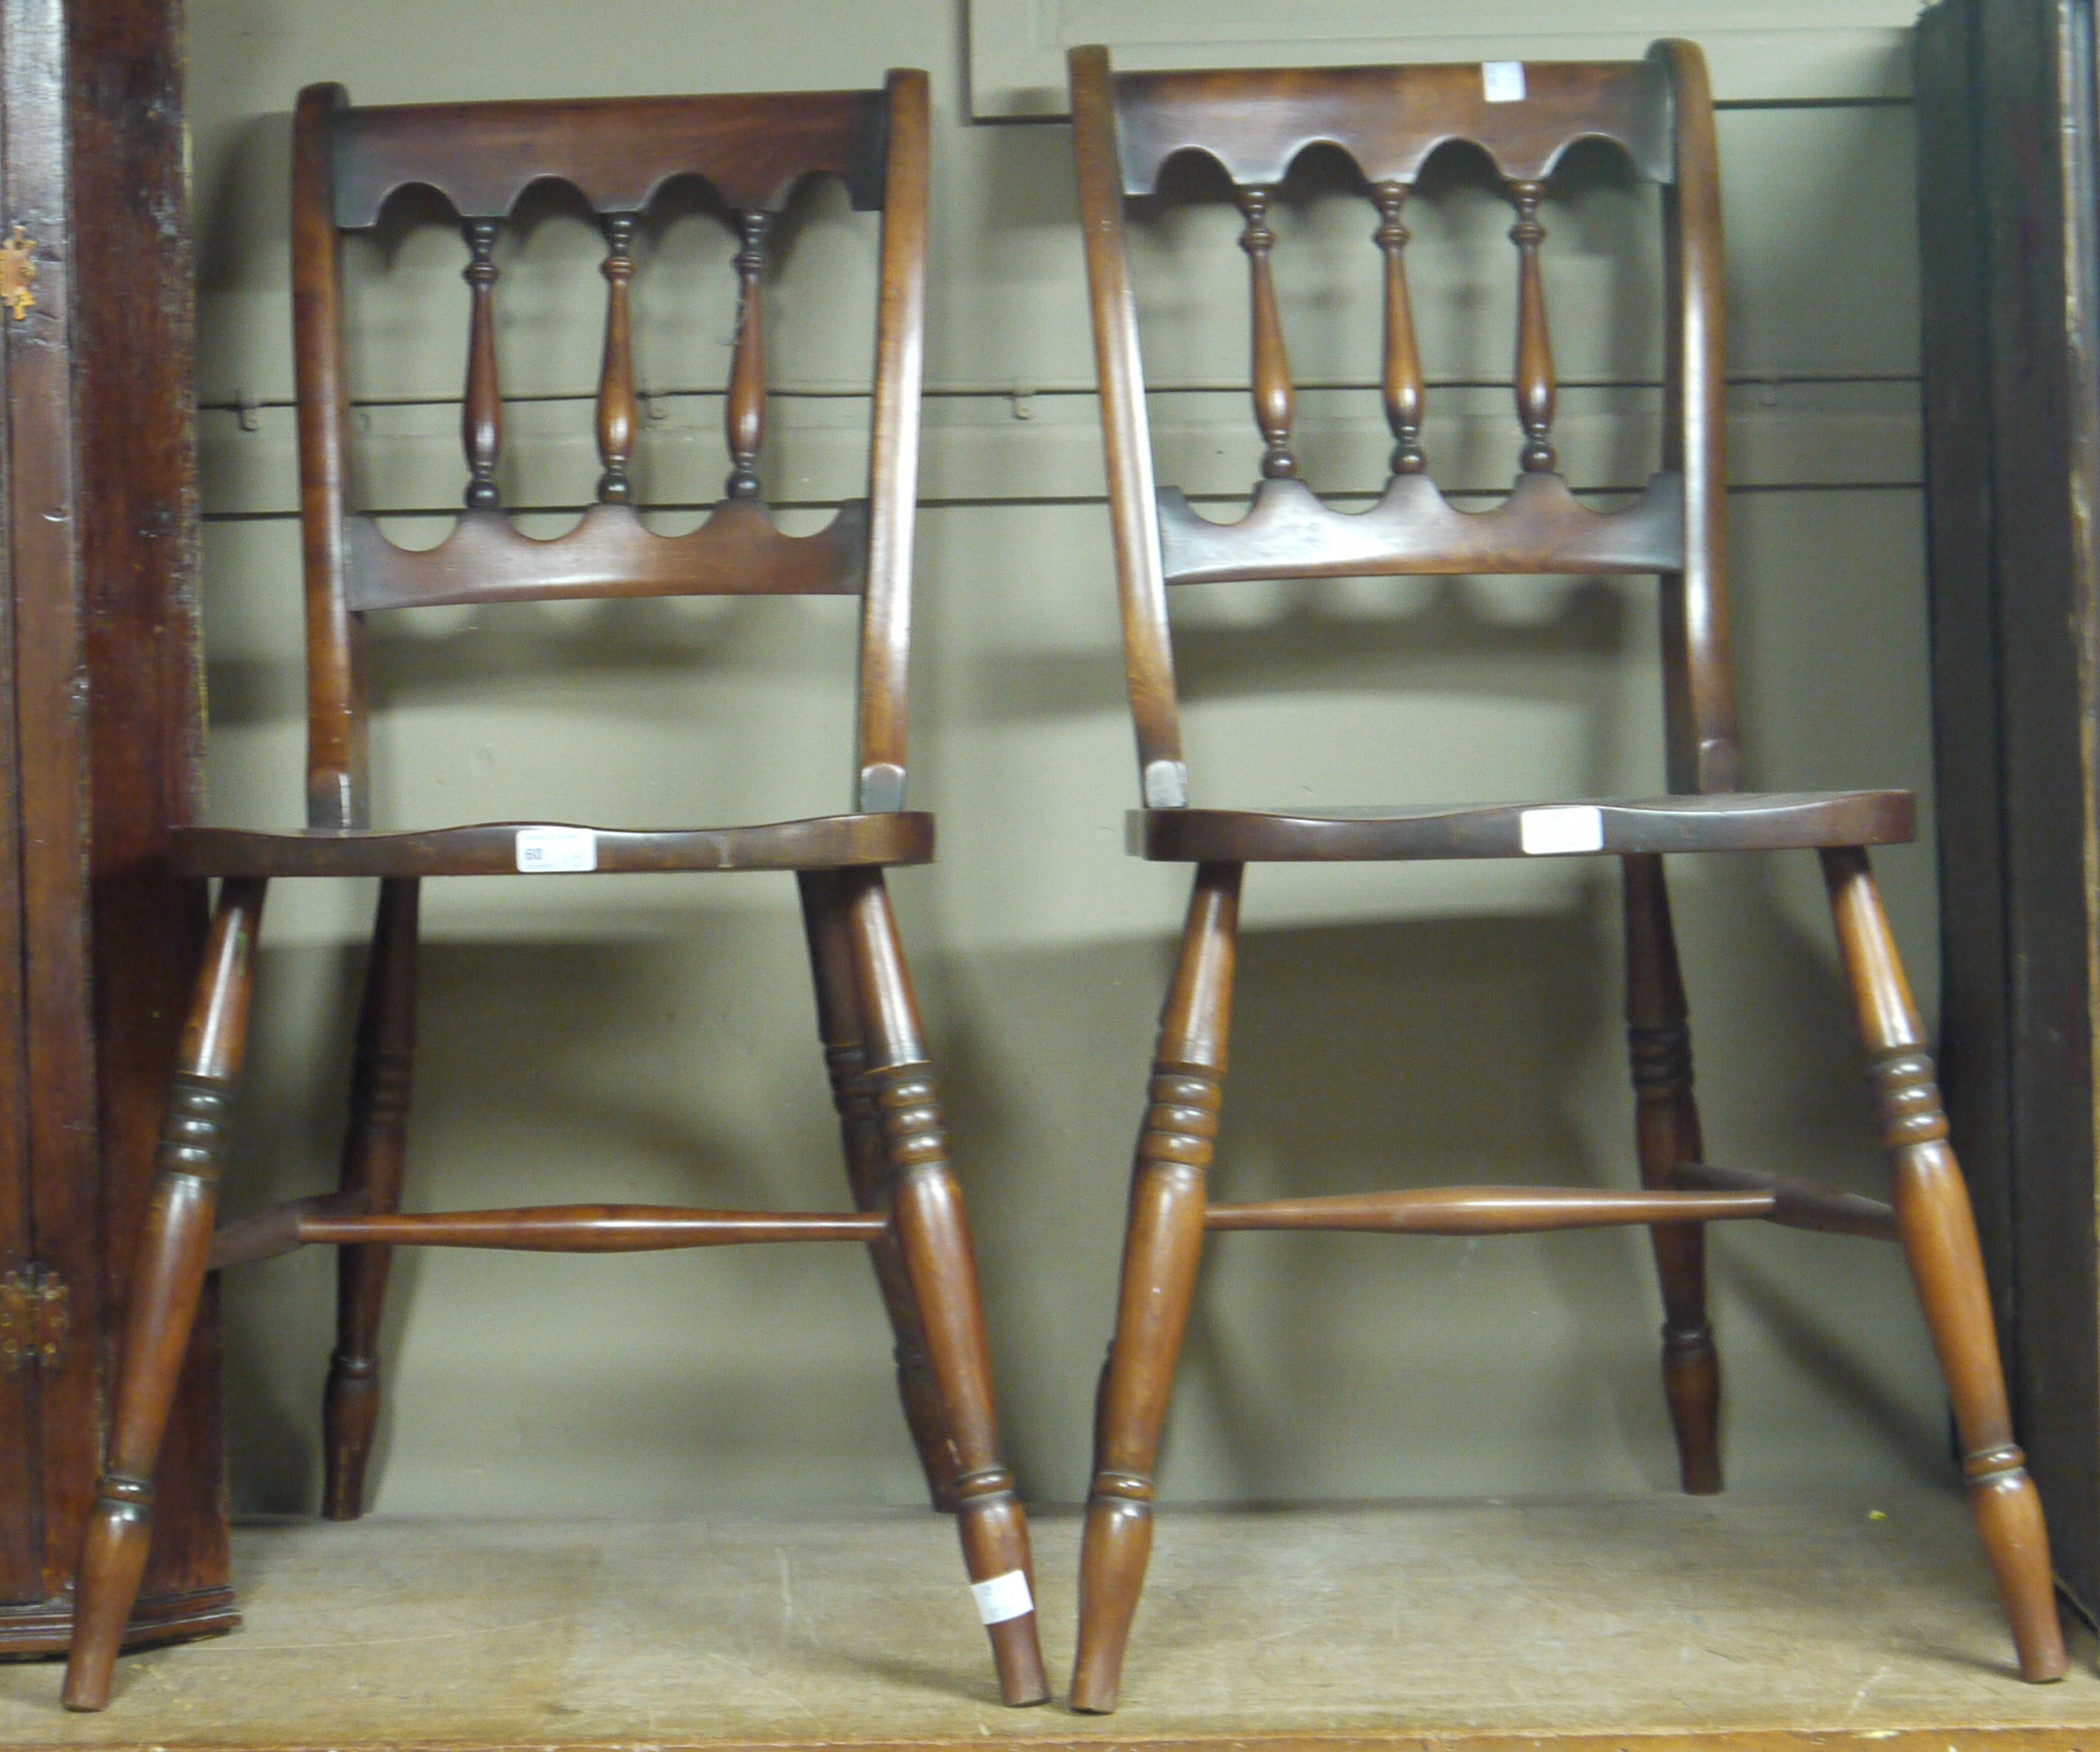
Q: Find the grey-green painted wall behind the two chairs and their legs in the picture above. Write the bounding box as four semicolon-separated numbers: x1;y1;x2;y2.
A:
191;0;1949;1513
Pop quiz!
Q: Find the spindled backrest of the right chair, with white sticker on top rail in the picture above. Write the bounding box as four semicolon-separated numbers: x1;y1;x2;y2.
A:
1071;42;1737;809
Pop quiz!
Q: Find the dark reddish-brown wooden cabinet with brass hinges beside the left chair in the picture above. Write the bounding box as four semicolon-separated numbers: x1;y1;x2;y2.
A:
0;0;235;1653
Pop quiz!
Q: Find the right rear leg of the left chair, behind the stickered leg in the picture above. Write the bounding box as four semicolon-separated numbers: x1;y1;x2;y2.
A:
798;870;956;1515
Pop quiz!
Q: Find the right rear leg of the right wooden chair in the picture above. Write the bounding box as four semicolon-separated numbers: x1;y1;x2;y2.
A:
1623;853;1720;1496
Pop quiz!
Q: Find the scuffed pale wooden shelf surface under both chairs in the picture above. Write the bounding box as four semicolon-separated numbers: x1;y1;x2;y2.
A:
0;1490;2100;1752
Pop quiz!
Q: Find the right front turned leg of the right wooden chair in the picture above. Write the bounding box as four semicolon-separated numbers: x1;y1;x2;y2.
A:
1823;847;2067;1681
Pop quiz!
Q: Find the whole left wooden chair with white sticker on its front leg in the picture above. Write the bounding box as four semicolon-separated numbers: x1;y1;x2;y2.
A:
65;71;1048;1710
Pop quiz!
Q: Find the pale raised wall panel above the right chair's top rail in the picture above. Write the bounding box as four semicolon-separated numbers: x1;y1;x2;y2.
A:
968;0;1917;122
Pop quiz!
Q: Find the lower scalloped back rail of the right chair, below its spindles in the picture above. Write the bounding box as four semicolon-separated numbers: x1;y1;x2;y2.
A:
1159;469;1684;584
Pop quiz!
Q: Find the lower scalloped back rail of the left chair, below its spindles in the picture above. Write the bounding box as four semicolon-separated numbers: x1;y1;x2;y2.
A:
346;500;867;611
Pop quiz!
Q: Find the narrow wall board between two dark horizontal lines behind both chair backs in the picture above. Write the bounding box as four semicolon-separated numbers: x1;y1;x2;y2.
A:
201;382;1922;517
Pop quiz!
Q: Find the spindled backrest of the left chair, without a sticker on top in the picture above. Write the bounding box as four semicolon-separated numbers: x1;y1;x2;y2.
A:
292;71;928;830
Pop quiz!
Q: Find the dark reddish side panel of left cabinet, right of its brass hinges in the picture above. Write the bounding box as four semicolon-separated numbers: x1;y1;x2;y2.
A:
59;0;231;1641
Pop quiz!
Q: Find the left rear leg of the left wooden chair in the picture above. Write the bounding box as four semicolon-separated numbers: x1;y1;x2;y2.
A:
321;876;418;1521
